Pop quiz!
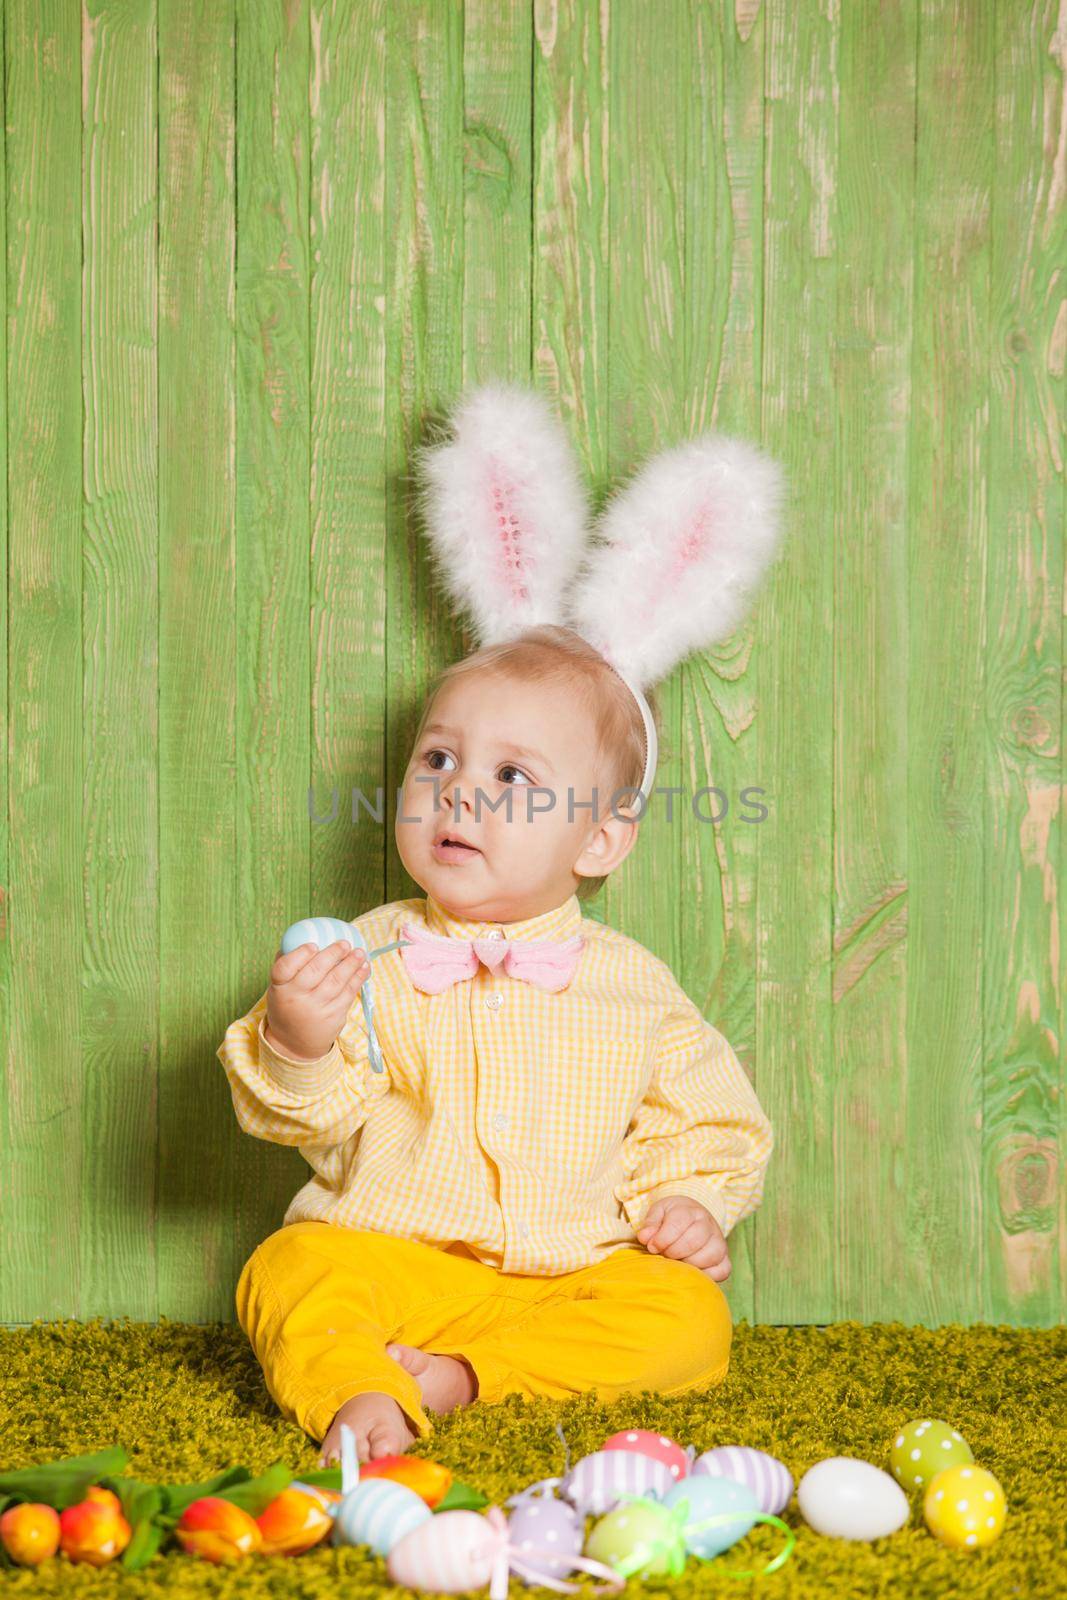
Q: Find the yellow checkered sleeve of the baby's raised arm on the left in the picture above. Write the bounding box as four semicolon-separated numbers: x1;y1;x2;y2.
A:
216;994;389;1144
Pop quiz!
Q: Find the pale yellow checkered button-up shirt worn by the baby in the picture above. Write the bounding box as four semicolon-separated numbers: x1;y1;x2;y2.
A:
218;894;773;1277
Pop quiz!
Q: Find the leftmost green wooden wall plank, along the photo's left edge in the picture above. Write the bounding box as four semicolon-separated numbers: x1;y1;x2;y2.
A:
0;0;85;1322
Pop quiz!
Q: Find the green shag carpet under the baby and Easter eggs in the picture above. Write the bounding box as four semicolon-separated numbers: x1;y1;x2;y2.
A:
0;1320;1067;1600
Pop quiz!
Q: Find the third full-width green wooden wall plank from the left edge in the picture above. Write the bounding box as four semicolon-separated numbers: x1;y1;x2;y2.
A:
157;0;245;1322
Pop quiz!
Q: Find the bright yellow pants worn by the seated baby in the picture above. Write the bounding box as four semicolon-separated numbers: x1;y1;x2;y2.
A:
237;1222;733;1442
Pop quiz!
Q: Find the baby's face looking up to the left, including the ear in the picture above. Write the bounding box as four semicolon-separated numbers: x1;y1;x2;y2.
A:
395;672;637;922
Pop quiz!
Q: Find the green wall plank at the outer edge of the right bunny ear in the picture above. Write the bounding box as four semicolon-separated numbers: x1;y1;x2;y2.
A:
755;0;841;1322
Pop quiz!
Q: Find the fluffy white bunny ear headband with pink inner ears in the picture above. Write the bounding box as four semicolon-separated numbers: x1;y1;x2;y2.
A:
416;382;785;814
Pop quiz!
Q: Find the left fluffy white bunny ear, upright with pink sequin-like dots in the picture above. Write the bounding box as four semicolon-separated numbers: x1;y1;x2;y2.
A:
414;382;587;645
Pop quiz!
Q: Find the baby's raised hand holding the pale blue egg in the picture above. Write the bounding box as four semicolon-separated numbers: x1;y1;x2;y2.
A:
267;939;371;1061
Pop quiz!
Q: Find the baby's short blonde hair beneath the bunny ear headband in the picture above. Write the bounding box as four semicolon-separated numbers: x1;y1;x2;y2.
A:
414;622;661;901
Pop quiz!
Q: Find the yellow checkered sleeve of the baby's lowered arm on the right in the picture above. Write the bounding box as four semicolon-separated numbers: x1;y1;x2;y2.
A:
614;984;774;1235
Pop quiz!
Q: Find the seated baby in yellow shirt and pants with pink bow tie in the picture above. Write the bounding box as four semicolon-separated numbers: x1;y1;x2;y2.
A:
218;624;773;1464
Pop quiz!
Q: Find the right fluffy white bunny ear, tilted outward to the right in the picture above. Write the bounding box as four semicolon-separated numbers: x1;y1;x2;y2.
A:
566;434;785;688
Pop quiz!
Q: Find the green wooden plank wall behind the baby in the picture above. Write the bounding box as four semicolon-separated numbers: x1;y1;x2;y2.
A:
0;0;1067;1325
